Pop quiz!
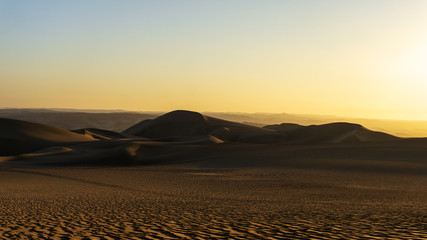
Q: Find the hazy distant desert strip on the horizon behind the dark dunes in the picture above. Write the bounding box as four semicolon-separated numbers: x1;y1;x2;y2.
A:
0;109;427;137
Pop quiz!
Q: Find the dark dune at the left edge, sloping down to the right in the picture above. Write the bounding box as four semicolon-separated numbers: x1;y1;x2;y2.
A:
0;118;95;155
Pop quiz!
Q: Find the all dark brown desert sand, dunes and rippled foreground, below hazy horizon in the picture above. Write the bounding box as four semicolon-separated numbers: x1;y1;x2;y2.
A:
0;111;427;239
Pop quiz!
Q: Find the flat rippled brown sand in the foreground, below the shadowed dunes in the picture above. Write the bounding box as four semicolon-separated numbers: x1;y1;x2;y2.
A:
0;163;427;239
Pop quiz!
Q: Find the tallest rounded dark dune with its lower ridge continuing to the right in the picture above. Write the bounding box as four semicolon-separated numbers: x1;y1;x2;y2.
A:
123;111;399;143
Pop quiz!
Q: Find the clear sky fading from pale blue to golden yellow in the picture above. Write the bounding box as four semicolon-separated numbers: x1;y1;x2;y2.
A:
0;0;427;120
